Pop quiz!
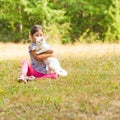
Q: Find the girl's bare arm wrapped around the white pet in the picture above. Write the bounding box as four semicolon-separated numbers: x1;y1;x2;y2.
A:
30;50;53;60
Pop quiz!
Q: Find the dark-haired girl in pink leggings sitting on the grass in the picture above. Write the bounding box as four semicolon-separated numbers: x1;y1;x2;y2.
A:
18;25;58;83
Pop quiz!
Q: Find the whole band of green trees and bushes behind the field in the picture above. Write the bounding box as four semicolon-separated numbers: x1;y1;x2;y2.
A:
0;0;120;43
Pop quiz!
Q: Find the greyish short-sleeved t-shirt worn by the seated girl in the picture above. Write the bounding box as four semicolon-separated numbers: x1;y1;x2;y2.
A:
28;43;47;74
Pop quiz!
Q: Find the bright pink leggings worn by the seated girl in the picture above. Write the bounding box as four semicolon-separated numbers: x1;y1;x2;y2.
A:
21;60;58;79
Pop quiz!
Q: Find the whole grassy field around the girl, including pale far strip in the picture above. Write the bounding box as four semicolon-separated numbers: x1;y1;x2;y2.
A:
0;43;120;120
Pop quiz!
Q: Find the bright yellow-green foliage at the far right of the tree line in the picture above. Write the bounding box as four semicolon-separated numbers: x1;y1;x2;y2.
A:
104;0;120;41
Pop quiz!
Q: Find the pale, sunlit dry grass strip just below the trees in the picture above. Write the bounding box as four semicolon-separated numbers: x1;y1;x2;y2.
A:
0;43;120;60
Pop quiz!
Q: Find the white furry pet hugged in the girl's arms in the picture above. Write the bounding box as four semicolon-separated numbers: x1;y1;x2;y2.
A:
35;37;67;76
